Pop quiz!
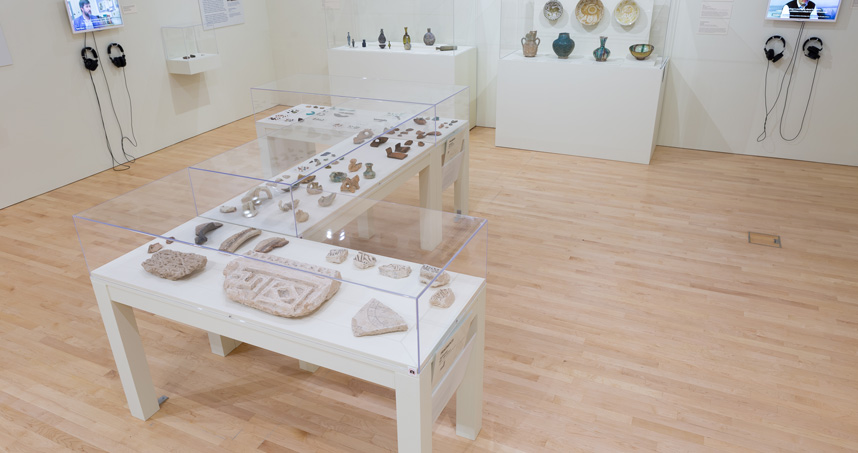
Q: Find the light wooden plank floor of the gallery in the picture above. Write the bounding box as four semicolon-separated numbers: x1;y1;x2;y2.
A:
0;119;858;453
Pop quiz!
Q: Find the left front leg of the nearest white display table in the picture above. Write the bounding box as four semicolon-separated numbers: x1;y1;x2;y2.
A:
92;281;160;420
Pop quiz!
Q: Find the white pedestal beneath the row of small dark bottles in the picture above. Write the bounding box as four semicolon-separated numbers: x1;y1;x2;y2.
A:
328;42;477;125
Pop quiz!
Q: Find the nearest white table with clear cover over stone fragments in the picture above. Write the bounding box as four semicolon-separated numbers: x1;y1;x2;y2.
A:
74;164;488;452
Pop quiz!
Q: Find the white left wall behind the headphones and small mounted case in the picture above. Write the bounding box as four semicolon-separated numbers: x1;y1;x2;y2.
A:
0;0;274;207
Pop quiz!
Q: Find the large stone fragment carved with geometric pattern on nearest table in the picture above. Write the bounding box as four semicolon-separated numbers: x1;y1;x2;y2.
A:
223;252;342;318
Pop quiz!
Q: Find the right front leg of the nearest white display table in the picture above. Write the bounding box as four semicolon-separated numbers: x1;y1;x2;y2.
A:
396;373;433;453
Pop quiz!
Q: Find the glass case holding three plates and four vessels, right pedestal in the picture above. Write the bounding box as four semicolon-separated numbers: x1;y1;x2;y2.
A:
500;0;673;67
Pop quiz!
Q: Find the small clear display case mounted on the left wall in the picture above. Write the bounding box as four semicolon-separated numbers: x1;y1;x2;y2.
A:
161;24;220;75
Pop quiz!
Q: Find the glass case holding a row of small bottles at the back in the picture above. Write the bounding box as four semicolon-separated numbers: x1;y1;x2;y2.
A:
324;0;476;53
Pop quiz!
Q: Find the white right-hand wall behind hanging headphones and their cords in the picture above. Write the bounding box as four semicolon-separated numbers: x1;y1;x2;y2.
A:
659;0;858;165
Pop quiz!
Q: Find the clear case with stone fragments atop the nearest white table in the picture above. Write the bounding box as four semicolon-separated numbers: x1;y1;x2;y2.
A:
74;164;488;374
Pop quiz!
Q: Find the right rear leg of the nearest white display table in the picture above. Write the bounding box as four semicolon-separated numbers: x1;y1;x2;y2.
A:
456;289;486;440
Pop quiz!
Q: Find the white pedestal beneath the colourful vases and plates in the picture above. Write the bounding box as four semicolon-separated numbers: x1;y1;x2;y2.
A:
495;52;667;164
